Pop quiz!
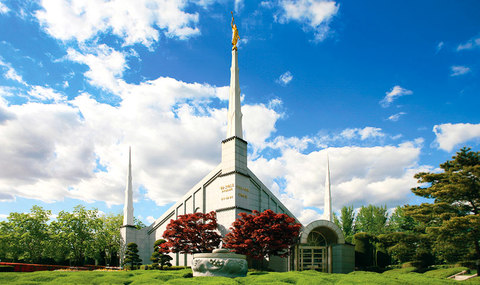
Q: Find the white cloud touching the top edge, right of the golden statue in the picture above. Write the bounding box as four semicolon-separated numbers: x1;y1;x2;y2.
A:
278;0;340;41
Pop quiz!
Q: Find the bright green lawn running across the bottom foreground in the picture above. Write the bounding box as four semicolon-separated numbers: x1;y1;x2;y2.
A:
0;269;480;285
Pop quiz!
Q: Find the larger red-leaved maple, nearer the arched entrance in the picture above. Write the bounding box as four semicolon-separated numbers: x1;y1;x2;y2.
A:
224;210;302;259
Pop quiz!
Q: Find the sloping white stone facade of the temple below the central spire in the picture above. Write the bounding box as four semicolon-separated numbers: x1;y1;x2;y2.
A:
121;160;293;269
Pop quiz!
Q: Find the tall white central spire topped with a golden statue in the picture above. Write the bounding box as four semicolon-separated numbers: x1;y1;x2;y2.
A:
227;13;243;139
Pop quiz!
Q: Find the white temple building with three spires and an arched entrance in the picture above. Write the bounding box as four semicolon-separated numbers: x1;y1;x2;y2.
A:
120;18;354;273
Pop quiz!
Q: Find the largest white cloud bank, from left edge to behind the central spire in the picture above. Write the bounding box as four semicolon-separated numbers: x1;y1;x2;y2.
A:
0;72;281;205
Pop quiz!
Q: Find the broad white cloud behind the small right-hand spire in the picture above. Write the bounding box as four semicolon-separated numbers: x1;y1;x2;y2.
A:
249;139;431;222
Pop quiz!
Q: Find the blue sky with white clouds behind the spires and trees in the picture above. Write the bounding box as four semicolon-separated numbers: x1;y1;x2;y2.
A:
0;0;480;224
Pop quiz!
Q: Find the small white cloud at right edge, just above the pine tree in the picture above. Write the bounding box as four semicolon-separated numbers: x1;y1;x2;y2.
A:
433;123;480;152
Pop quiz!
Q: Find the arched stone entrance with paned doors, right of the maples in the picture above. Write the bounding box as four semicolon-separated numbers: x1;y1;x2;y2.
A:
295;220;345;272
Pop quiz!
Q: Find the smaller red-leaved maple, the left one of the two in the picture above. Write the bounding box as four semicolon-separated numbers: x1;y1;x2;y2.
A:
160;211;221;253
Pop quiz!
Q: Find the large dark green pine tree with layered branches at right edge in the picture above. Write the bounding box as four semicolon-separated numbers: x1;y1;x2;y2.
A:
407;147;480;262
